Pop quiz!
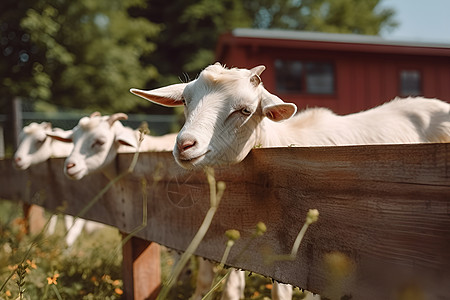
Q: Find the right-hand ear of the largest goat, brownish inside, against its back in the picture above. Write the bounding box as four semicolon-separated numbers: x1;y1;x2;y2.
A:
261;90;297;122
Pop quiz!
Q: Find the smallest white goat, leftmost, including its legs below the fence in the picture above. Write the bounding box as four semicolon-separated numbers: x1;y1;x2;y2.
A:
13;122;96;247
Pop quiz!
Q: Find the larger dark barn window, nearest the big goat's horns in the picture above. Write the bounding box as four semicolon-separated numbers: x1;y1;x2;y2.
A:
275;59;334;95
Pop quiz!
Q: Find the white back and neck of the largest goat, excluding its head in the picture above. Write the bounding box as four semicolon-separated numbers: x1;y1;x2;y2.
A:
257;97;450;147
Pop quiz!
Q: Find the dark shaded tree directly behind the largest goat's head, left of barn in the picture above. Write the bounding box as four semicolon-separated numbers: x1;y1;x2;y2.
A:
131;0;251;87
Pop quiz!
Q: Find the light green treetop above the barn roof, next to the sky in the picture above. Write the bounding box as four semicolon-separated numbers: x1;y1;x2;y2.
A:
243;0;397;35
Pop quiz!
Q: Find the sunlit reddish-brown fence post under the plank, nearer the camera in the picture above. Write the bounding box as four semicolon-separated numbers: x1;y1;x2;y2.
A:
122;233;161;300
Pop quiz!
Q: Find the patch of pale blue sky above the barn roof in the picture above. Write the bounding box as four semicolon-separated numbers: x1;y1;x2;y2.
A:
381;0;450;44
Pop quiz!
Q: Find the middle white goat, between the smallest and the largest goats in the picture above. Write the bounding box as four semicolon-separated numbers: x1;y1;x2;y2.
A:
49;113;176;180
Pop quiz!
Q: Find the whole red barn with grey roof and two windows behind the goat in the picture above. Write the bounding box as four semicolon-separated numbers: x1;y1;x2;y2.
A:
216;29;450;114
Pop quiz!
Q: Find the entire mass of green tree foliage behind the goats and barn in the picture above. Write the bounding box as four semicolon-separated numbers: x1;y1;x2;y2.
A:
0;0;395;112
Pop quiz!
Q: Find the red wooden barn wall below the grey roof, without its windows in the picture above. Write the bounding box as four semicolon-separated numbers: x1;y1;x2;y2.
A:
217;37;450;114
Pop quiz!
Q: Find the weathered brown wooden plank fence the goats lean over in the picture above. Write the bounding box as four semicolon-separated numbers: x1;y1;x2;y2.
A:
0;144;450;299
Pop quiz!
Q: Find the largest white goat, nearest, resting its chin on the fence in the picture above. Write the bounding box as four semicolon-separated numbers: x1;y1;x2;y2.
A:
130;63;450;299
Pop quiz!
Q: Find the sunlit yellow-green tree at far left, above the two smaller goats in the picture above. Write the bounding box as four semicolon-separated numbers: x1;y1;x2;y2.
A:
0;0;160;112
